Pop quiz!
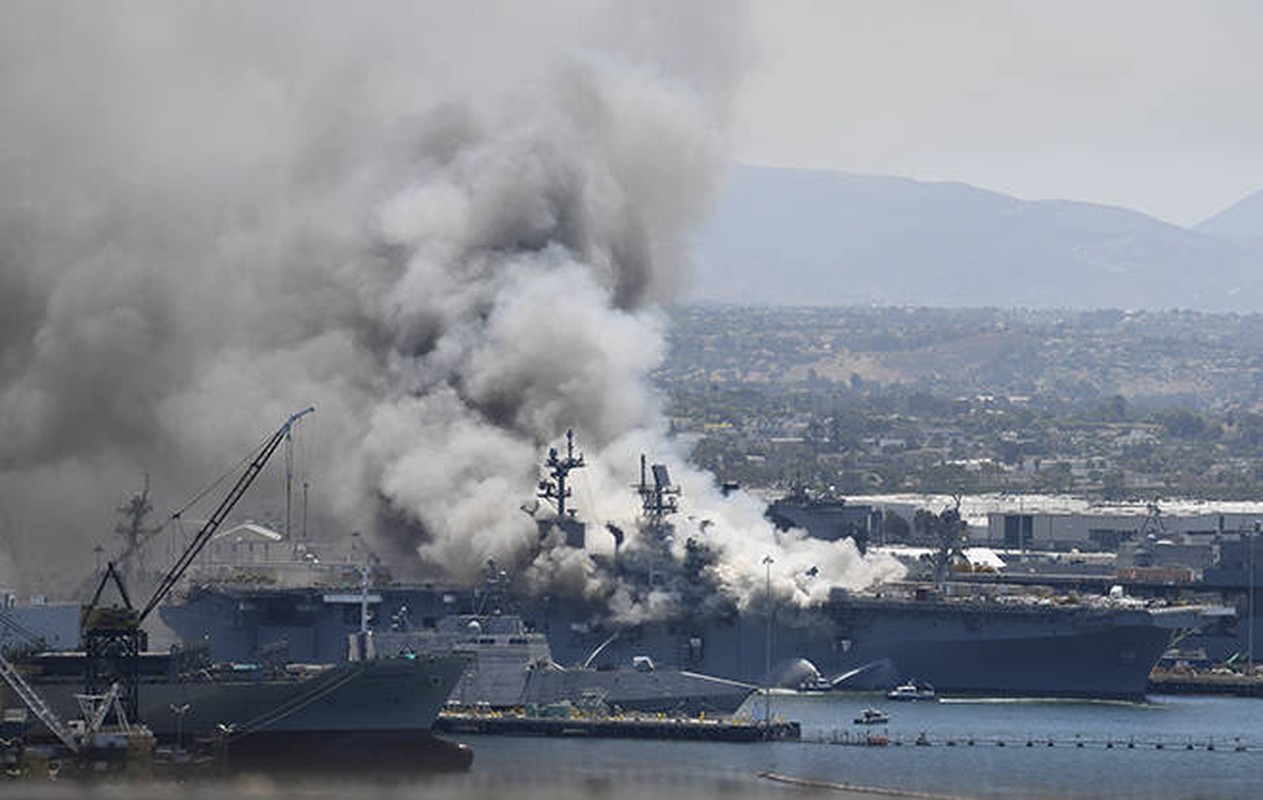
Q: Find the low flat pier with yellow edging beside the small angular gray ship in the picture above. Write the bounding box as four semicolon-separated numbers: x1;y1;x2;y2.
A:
434;712;802;742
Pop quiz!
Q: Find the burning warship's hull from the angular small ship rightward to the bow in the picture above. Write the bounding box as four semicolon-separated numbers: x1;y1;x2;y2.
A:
530;600;1173;699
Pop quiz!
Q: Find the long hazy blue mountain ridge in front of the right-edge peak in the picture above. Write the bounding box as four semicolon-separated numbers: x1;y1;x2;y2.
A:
691;166;1263;311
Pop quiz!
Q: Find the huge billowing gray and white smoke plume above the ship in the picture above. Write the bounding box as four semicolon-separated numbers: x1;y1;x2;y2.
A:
0;0;899;601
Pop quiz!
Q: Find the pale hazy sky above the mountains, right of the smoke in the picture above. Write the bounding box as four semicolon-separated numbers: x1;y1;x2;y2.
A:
733;0;1263;225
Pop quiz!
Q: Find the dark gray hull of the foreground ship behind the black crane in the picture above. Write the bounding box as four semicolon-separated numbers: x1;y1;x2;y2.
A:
21;648;466;766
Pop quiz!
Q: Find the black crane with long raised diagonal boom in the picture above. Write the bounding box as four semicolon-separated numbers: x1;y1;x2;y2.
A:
80;406;316;719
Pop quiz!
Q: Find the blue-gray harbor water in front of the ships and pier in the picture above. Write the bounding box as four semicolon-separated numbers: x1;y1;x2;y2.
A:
12;693;1263;800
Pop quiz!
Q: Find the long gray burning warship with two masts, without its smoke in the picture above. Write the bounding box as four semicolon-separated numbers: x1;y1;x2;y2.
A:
147;429;1201;698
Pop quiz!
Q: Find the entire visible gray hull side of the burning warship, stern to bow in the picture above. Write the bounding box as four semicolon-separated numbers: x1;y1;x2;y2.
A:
163;586;1172;698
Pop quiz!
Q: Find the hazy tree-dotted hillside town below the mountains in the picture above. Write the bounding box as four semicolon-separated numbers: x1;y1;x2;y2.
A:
655;307;1263;499
